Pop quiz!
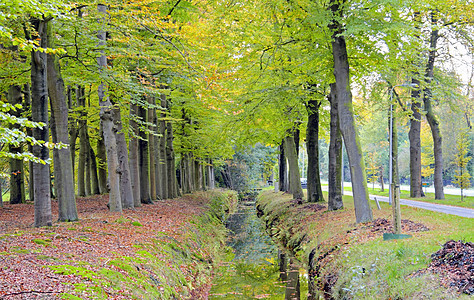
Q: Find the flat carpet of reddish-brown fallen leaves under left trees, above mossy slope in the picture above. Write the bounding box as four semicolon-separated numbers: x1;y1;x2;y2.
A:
0;196;206;299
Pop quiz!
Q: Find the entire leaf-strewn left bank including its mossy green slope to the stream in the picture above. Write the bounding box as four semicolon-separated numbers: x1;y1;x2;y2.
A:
0;192;235;299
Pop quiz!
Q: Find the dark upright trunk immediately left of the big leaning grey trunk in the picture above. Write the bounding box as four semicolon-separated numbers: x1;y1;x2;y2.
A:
328;83;344;210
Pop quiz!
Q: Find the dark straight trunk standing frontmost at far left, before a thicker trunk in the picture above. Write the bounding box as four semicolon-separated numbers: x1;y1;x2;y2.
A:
31;19;52;227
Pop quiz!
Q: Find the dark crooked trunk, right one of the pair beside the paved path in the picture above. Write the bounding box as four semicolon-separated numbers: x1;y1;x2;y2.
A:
423;18;444;200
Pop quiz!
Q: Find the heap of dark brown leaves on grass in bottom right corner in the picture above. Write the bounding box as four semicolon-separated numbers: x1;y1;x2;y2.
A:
428;240;474;295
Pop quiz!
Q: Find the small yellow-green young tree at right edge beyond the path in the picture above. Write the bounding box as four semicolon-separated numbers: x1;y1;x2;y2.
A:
453;130;471;201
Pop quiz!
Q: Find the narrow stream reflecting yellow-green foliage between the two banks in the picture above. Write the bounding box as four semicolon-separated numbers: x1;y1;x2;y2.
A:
209;193;307;300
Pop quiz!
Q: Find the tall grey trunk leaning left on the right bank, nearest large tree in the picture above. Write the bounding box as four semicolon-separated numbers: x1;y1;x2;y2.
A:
329;0;373;223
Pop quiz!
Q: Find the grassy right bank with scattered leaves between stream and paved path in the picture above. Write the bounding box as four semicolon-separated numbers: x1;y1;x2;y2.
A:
258;191;474;299
